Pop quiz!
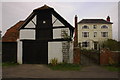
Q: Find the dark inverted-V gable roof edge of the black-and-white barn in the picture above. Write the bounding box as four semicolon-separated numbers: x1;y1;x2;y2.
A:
19;5;74;30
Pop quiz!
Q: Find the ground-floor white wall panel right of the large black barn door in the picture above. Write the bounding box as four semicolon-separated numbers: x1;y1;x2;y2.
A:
48;42;63;63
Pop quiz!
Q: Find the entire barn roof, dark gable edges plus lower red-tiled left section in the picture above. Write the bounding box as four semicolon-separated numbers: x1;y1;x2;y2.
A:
2;5;74;42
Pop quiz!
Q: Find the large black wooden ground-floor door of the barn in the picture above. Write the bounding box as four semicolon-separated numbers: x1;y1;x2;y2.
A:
23;41;48;64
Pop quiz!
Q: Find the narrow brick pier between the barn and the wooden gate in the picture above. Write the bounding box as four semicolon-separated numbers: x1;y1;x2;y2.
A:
73;47;80;64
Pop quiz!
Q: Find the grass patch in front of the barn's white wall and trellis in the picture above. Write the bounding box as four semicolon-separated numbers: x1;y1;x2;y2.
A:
48;63;82;71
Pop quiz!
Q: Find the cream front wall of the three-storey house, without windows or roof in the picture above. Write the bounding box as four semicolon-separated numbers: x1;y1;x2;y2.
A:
78;23;112;49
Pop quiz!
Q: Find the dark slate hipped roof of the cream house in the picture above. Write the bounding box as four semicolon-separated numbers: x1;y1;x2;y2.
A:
78;19;113;24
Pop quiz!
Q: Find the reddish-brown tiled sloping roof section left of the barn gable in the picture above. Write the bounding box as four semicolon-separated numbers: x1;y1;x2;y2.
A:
2;21;24;42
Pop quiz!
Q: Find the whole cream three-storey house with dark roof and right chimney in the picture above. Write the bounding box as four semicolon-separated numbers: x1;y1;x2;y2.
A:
78;16;113;50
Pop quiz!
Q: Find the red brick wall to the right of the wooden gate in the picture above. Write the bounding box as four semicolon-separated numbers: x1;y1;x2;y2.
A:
100;49;120;65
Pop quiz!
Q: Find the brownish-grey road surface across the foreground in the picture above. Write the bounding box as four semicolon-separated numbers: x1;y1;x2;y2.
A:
3;64;118;78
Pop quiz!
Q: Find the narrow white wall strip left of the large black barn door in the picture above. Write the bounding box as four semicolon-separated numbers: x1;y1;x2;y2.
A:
17;40;23;64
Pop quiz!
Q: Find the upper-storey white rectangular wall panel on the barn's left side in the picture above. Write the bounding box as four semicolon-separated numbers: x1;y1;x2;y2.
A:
20;29;35;40
